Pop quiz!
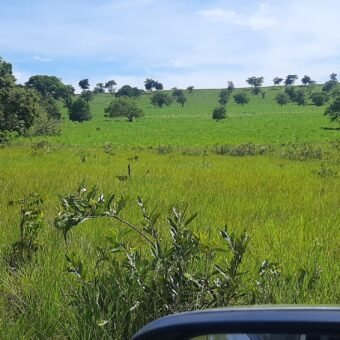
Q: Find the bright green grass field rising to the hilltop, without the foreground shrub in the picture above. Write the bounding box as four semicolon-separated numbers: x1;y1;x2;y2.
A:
0;88;340;339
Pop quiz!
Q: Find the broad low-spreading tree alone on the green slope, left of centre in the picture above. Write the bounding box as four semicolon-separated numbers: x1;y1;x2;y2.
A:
105;97;144;122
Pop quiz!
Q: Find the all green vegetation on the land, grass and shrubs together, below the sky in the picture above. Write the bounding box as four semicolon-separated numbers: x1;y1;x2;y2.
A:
0;55;340;339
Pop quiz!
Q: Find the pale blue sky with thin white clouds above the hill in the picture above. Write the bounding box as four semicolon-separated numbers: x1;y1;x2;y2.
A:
0;0;340;89
